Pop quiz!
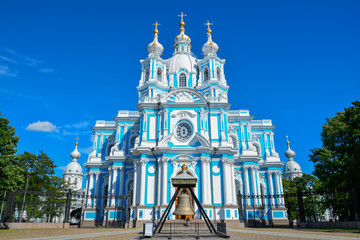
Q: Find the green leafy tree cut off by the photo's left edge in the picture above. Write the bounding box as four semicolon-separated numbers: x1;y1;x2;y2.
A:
0;114;24;193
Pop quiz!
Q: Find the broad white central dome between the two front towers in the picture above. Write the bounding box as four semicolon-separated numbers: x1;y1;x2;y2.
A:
167;53;197;74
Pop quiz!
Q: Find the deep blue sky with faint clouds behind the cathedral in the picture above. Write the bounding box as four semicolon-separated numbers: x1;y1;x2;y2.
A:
0;0;360;181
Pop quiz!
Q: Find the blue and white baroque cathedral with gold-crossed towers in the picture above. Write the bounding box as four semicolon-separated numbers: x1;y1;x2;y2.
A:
64;14;301;226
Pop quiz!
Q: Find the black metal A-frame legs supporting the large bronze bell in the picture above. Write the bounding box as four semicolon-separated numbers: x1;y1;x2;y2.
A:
154;187;229;238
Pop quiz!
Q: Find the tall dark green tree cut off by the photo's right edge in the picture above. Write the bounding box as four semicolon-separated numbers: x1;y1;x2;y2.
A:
309;101;360;219
